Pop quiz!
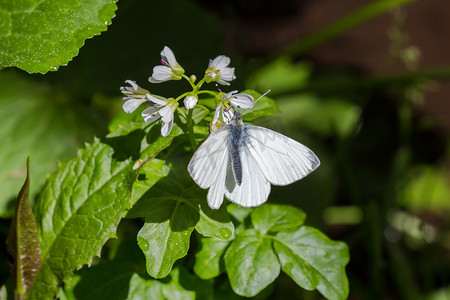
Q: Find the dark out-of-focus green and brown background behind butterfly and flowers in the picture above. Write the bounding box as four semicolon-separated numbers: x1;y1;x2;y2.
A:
0;0;450;300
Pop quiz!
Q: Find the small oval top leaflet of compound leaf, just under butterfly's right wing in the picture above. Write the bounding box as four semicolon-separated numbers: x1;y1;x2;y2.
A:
251;204;306;234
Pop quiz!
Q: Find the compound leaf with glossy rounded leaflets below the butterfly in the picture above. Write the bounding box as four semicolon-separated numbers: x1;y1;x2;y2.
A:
194;204;349;299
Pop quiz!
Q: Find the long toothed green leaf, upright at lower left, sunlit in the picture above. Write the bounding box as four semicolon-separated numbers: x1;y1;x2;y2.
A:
31;139;137;299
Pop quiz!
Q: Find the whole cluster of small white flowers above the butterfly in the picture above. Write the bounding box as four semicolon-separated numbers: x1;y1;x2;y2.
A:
120;46;254;136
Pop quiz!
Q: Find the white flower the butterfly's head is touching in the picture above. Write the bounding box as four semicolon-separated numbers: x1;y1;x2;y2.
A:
212;91;254;125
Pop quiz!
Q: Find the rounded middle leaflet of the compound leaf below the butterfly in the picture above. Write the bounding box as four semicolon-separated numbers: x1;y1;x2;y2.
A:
225;229;280;297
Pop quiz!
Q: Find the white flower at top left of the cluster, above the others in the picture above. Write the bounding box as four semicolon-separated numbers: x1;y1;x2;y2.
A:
148;46;184;83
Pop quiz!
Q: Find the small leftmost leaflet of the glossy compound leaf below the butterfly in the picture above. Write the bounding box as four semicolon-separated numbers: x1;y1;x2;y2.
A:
194;238;230;279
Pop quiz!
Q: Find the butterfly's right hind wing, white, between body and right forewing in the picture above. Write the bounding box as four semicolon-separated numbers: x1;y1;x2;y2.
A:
225;144;270;207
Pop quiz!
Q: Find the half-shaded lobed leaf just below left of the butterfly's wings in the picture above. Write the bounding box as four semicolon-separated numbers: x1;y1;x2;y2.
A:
127;168;234;278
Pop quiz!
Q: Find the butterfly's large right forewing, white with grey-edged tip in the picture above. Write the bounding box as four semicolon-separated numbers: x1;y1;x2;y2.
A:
246;125;320;185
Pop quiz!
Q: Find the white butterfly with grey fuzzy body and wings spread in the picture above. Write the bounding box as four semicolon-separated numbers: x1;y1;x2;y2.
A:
188;111;320;209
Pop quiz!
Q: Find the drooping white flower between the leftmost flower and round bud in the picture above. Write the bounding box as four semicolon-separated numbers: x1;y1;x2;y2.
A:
142;94;178;136
